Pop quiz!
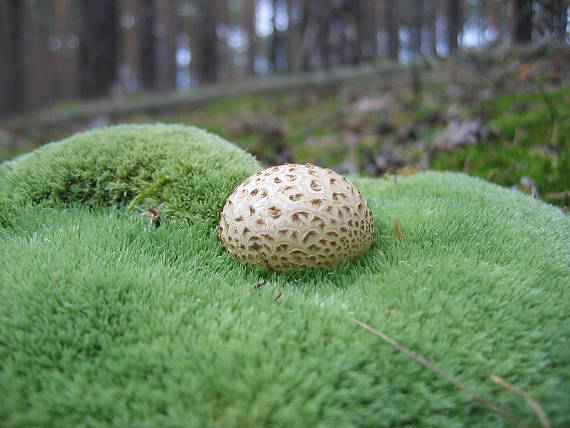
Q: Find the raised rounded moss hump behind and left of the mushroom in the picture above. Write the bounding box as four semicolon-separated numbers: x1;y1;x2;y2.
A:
0;125;259;224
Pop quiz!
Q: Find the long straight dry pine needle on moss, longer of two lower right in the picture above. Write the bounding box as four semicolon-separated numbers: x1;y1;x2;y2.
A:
348;314;532;428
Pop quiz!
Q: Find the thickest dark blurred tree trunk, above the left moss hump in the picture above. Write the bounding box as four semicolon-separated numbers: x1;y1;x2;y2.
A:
79;0;119;98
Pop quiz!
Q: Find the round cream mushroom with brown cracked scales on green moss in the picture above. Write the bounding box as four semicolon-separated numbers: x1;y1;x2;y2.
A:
220;164;374;272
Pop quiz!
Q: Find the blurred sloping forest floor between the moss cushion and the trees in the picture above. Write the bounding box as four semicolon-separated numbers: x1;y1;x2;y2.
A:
0;42;570;210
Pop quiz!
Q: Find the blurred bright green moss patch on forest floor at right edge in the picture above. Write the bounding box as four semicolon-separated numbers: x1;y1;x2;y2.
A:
432;88;570;205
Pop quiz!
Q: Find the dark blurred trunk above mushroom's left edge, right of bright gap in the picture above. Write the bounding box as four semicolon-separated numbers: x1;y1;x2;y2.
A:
196;0;220;83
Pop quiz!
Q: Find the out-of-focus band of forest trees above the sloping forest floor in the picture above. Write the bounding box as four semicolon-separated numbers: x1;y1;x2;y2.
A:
0;0;568;117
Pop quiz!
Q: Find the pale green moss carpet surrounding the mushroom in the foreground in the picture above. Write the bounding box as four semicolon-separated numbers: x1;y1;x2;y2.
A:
0;126;570;427
